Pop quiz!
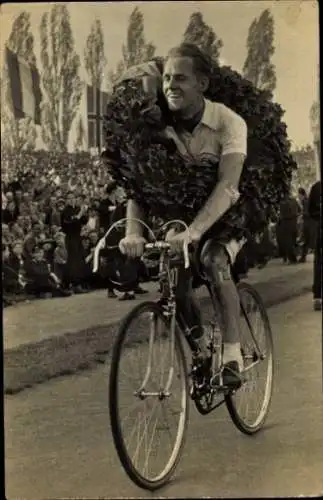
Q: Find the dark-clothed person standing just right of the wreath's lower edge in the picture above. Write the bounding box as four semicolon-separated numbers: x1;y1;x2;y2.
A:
277;195;301;264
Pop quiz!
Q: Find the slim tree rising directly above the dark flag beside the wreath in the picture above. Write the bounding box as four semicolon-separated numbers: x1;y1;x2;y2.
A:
84;19;107;89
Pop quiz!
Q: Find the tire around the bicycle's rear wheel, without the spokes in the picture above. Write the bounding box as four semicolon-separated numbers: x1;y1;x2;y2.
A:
225;282;274;435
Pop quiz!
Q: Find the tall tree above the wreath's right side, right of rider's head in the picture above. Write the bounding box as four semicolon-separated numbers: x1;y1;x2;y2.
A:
243;9;276;92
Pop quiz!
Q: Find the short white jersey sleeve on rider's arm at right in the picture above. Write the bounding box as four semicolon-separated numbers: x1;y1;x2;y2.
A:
220;102;247;156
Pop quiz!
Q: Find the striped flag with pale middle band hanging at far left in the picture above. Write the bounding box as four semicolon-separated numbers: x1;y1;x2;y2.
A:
6;47;42;125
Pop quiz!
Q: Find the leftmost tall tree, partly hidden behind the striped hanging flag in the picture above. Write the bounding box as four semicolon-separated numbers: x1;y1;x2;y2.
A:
1;11;37;153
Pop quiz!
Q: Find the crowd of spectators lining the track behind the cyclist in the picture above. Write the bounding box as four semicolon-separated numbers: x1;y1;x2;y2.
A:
2;148;314;304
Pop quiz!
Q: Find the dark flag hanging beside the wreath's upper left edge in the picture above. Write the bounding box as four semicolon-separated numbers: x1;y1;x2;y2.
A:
87;85;109;152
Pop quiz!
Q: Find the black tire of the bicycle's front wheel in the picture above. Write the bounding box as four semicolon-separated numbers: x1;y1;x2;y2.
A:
109;301;189;491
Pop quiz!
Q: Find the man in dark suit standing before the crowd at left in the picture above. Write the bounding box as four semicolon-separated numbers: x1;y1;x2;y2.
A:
61;192;87;293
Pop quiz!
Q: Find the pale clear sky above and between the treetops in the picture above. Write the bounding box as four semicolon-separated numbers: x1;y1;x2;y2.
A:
0;0;319;147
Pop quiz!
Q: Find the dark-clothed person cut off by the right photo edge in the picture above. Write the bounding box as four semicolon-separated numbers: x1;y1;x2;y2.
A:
308;181;322;311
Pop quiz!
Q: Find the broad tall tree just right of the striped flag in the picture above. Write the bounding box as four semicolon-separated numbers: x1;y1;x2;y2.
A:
40;4;83;151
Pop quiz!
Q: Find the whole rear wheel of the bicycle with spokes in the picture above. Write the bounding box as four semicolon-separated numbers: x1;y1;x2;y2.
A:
225;283;273;434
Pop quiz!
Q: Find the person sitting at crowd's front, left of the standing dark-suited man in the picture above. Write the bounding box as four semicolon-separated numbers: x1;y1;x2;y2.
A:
25;246;71;298
